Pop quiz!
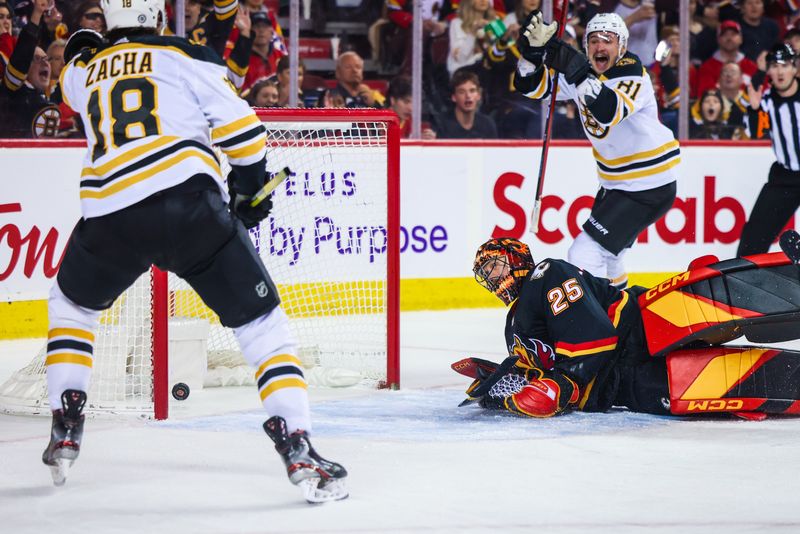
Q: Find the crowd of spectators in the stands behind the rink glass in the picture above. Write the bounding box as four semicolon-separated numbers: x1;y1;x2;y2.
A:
0;0;800;139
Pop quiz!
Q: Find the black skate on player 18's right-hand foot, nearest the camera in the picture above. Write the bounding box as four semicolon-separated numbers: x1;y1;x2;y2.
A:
264;415;348;503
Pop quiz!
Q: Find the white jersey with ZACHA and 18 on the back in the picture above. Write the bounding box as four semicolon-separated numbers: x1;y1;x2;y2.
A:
60;36;266;218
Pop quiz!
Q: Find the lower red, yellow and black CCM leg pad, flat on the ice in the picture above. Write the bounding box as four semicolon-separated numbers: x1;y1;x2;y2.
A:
667;346;800;415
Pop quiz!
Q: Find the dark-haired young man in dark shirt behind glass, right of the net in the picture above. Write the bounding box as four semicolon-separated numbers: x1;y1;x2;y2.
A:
438;68;497;139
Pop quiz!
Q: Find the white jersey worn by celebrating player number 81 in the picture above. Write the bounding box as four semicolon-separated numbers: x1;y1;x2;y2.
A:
517;53;680;191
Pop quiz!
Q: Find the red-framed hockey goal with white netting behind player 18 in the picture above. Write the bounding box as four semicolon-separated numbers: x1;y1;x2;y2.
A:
0;109;399;419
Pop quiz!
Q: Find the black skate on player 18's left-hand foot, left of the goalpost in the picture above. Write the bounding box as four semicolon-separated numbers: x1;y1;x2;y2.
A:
42;389;86;486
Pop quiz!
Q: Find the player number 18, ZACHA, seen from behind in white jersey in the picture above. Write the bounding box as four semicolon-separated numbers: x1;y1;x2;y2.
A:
42;0;347;502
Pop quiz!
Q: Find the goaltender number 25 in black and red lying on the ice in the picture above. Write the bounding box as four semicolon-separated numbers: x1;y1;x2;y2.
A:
452;230;800;420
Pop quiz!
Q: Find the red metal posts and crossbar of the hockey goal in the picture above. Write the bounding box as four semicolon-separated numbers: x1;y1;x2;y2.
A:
151;108;400;420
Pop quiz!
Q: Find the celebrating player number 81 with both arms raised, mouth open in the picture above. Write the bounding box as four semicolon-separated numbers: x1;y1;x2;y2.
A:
514;11;680;287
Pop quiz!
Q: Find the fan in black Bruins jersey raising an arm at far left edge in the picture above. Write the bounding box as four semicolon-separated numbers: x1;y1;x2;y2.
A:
0;0;61;137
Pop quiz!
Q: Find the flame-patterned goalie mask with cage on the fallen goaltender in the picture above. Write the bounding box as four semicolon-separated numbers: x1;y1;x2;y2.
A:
472;241;533;306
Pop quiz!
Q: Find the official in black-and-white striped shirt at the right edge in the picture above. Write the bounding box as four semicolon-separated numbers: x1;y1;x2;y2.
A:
736;44;800;256
